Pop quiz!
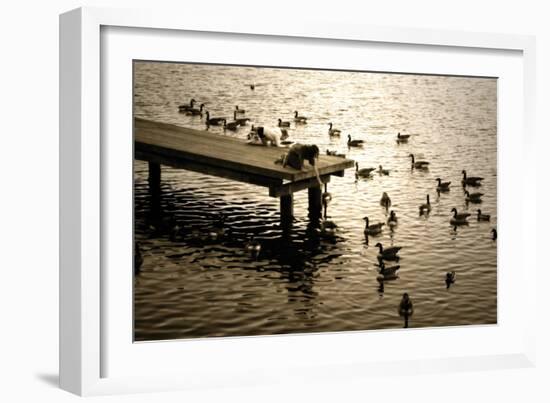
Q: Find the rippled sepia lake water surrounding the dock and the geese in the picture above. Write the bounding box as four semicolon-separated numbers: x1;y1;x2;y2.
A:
134;62;497;341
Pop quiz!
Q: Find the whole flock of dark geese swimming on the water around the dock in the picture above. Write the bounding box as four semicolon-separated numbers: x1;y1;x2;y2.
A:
153;98;497;326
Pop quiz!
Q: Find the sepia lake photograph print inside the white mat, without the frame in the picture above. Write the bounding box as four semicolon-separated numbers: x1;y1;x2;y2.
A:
133;60;498;342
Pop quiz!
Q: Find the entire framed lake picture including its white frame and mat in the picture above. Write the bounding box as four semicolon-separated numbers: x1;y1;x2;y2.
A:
60;8;535;395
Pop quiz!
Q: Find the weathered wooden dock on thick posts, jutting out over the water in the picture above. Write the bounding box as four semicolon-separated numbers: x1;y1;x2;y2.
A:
134;118;354;227
